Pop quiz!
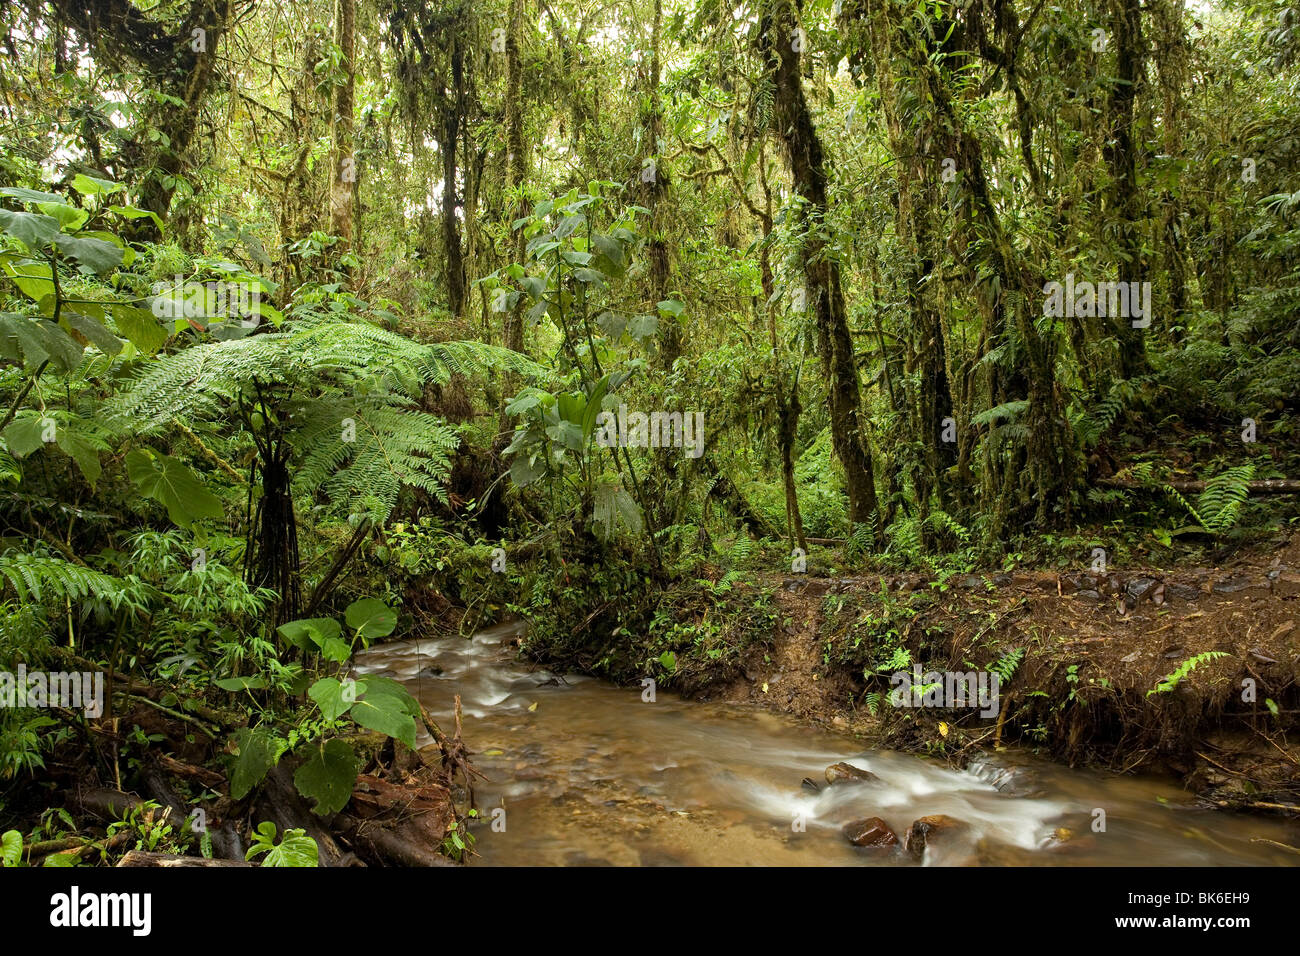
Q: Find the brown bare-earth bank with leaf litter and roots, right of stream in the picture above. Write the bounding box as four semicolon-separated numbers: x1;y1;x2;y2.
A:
702;535;1300;812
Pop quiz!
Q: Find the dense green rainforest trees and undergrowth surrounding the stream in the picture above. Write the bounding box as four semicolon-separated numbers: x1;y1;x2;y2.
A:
0;0;1300;864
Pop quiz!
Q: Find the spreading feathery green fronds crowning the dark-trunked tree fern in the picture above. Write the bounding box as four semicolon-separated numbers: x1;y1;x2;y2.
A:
111;315;542;522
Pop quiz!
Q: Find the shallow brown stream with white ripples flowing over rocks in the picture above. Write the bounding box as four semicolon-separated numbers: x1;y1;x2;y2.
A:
358;624;1300;866
